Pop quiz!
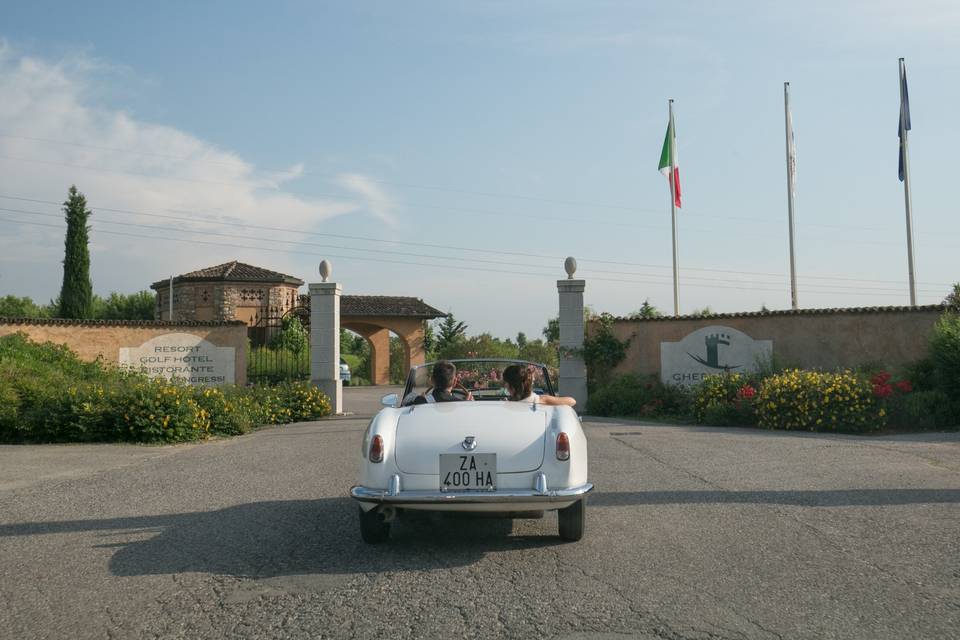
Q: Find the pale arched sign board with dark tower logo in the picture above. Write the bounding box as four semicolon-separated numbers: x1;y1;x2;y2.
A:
660;326;773;386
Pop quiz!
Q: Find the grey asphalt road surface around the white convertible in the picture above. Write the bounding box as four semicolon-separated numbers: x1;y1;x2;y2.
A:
0;389;960;640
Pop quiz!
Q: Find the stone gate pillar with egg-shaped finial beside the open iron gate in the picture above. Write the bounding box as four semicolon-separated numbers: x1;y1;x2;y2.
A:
310;260;343;414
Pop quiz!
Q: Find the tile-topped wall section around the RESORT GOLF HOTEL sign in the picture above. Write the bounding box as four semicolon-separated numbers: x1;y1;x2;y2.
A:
0;318;247;385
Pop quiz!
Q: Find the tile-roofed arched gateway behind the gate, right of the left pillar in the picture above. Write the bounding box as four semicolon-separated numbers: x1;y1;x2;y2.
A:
340;296;446;384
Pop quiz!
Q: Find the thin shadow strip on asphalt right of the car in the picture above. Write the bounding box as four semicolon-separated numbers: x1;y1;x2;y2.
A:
590;489;960;507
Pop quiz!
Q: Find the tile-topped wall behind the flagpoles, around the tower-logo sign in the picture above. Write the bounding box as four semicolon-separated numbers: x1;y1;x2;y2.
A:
604;305;946;374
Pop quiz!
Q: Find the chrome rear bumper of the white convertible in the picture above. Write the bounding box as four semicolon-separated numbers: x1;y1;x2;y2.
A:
350;482;593;504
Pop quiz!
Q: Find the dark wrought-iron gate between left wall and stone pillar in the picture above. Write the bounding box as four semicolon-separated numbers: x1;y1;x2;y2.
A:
247;306;310;384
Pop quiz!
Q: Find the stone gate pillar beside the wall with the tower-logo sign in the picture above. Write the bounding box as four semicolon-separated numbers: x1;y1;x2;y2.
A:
557;258;587;413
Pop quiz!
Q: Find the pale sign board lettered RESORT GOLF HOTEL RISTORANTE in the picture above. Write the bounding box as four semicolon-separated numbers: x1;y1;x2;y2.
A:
120;333;236;385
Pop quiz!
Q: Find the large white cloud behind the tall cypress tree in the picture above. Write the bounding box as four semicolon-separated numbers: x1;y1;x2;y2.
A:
0;45;395;297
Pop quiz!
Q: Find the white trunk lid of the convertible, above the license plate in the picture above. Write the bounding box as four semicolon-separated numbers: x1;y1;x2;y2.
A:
396;401;547;474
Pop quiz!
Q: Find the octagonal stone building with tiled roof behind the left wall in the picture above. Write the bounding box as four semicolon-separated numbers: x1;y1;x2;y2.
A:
150;260;303;325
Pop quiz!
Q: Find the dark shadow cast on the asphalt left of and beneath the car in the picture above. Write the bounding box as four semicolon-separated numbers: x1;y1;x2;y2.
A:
0;498;561;578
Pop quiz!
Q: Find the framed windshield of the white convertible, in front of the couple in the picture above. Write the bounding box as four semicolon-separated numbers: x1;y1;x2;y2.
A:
403;359;554;404
